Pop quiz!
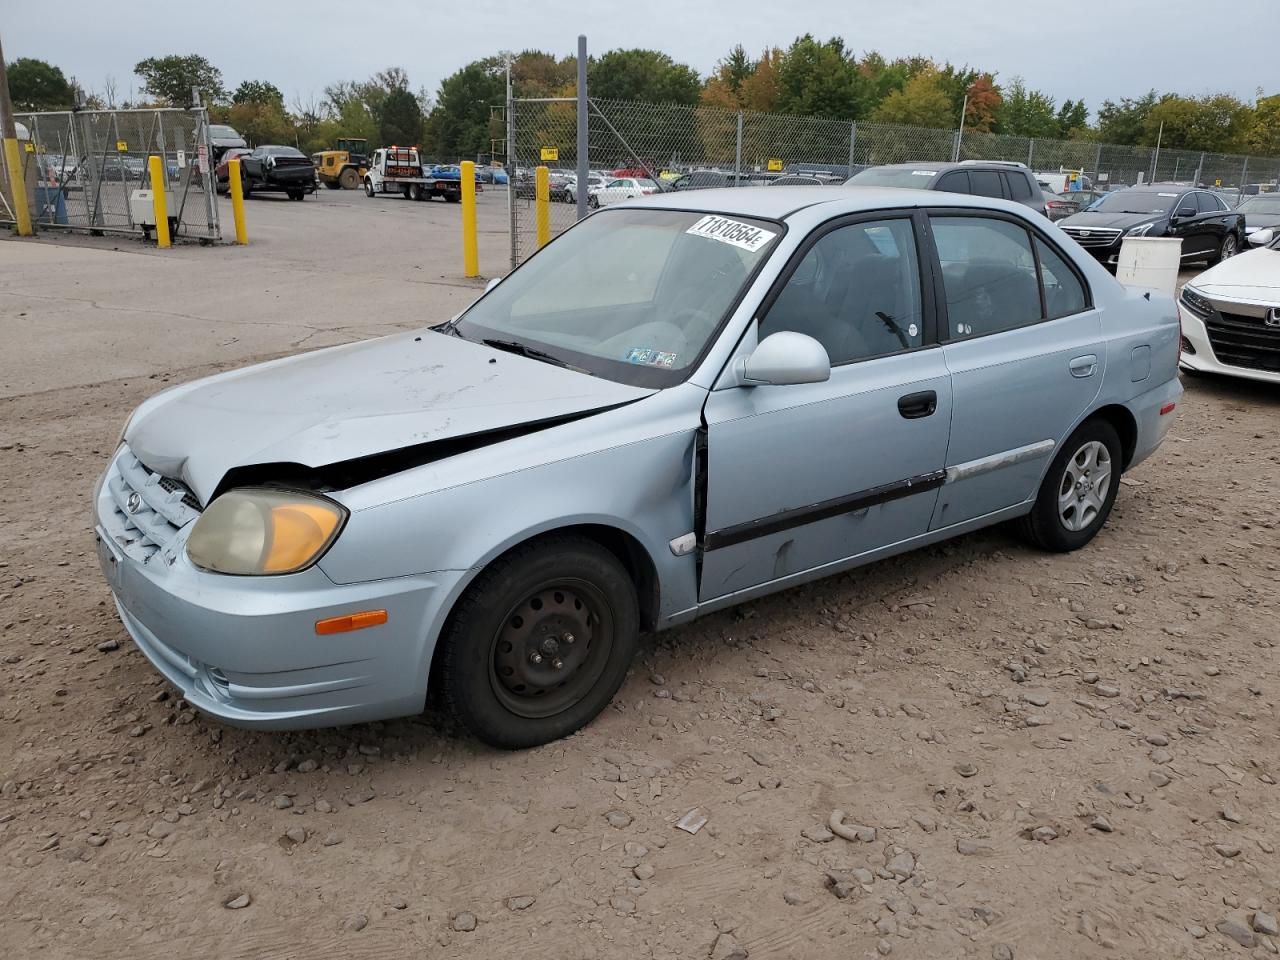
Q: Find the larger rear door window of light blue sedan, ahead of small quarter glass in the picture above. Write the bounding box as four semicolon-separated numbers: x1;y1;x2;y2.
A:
932;216;1042;339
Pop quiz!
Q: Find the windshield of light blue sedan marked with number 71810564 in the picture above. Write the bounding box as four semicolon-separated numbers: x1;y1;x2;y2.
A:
453;209;783;387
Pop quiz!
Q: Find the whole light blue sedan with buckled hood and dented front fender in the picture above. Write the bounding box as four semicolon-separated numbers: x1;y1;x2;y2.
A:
95;187;1181;748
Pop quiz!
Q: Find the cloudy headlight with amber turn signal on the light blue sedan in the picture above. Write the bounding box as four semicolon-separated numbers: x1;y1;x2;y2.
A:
187;486;347;576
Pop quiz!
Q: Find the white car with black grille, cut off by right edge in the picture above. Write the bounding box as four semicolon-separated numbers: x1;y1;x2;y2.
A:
1178;228;1280;384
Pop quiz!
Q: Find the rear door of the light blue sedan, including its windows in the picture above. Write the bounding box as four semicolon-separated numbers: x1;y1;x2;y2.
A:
929;209;1106;529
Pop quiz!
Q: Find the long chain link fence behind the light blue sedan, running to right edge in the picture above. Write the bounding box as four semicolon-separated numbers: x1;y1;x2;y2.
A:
507;99;1280;266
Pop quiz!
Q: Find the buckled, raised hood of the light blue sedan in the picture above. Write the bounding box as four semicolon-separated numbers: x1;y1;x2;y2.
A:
125;330;654;503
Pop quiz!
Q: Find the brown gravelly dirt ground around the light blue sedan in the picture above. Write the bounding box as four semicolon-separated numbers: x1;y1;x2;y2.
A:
0;212;1280;960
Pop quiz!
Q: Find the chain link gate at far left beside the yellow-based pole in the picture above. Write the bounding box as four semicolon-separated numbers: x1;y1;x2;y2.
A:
0;108;221;241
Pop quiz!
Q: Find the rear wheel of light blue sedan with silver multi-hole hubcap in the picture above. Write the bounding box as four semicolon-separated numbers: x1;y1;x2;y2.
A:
1021;419;1121;553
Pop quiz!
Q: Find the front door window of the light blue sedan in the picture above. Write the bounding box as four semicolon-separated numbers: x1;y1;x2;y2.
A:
759;218;924;365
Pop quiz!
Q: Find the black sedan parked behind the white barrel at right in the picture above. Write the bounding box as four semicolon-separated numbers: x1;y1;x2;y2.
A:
1057;183;1244;273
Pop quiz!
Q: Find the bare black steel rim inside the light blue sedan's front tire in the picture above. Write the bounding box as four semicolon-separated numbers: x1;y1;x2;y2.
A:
489;580;613;719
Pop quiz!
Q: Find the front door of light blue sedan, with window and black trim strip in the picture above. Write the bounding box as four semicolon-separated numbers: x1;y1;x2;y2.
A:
699;214;951;602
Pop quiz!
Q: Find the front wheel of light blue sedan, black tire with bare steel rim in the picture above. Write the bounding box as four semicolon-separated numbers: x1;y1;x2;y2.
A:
440;536;640;750
